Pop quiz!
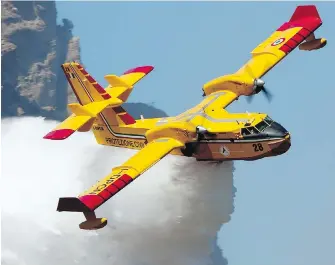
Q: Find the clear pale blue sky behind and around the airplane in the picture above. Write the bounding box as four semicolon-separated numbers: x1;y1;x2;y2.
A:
57;2;335;265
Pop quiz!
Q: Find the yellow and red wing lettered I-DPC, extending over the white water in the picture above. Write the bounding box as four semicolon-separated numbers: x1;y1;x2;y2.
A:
57;138;184;229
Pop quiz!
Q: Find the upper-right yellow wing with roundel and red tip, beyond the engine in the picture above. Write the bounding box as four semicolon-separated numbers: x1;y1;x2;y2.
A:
203;5;327;95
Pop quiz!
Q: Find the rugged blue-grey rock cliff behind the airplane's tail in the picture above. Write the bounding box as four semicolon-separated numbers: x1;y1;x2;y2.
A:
1;1;167;120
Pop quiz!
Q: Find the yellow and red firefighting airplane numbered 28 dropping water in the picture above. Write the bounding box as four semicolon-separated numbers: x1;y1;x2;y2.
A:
44;5;326;230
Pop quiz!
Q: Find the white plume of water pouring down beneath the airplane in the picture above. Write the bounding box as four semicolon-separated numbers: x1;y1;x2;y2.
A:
1;118;235;265
